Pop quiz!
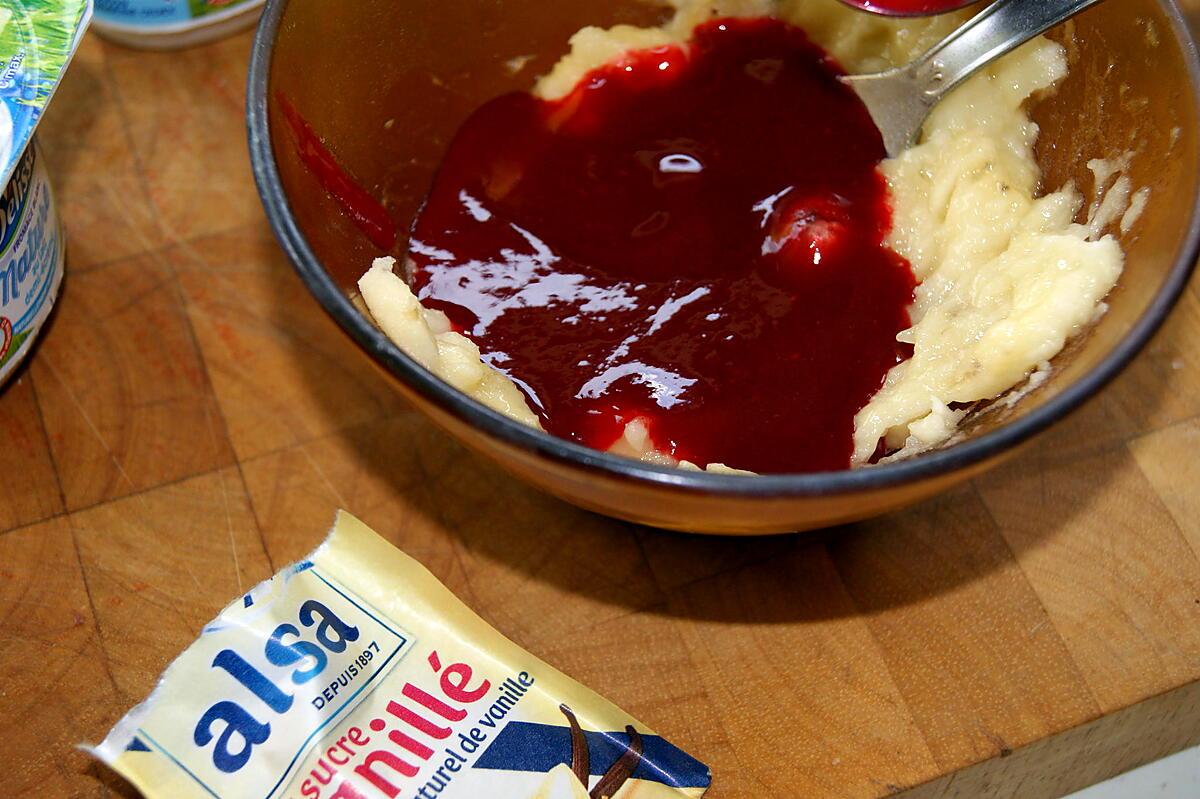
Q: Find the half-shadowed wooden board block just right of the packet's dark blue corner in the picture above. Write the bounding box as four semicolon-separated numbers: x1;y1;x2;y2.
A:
670;545;937;797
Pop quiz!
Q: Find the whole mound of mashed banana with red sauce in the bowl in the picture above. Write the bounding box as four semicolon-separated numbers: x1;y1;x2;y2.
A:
360;0;1123;473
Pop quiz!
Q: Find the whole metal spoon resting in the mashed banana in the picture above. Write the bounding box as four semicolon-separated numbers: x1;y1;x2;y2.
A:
841;0;1100;157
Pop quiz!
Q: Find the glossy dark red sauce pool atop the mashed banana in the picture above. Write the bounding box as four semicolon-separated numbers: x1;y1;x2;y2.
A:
409;19;914;473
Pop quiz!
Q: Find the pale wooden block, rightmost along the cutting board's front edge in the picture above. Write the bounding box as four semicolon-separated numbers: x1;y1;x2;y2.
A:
980;441;1200;711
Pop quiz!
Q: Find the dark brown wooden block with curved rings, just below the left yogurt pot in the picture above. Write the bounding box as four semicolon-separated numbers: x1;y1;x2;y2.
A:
31;253;233;510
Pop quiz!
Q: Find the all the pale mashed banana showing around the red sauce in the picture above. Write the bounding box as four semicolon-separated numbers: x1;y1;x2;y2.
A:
360;0;1128;474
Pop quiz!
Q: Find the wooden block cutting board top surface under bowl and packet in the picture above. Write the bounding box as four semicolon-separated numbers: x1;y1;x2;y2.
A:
7;17;1200;799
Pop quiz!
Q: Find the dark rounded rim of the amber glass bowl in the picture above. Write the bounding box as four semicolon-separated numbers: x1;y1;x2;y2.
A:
246;0;1200;498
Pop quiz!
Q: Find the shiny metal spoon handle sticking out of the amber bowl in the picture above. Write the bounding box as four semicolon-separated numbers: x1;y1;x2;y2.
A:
908;0;1100;106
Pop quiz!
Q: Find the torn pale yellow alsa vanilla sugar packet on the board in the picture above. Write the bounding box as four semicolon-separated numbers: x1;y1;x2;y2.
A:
90;512;710;799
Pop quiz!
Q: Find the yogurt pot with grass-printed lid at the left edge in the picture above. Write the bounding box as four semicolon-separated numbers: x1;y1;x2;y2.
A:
0;0;91;385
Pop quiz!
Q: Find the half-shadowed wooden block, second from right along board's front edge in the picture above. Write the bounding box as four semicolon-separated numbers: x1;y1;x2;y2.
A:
832;487;1098;771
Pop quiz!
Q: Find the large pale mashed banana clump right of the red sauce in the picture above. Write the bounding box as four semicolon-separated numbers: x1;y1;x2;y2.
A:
854;34;1128;465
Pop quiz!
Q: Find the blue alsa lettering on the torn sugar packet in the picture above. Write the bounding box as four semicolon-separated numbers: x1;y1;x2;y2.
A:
192;600;359;774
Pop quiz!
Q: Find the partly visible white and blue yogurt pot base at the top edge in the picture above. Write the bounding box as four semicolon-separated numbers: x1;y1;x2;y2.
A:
92;0;266;50
